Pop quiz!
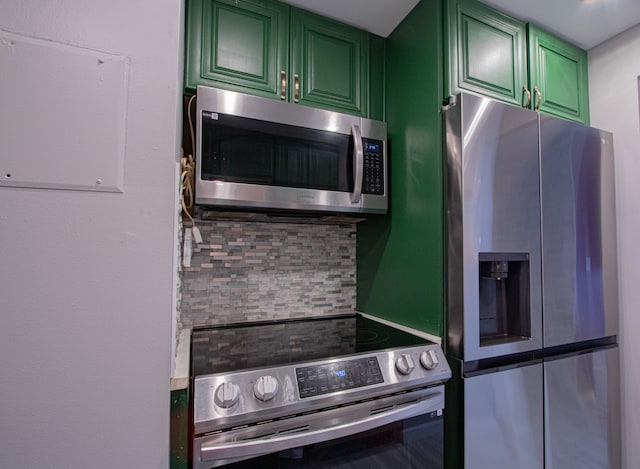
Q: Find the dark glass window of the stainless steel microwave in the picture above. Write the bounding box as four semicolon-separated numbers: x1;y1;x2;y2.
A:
201;113;353;192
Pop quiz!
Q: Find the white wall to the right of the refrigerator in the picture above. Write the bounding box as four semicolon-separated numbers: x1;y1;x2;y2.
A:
589;25;640;468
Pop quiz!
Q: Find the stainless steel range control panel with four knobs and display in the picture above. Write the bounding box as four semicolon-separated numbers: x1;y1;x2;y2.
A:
193;343;451;434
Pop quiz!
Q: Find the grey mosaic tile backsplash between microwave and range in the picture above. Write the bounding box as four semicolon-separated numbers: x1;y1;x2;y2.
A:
179;220;356;327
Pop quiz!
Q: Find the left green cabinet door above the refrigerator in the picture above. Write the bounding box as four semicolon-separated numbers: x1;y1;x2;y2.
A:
445;0;527;105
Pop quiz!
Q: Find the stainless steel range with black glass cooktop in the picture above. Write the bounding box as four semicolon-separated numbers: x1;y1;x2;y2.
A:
192;315;451;469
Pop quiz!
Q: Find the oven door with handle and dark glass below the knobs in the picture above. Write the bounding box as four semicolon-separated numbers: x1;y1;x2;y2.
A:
194;386;444;469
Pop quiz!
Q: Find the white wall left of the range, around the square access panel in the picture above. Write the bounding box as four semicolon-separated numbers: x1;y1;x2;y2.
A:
0;0;183;469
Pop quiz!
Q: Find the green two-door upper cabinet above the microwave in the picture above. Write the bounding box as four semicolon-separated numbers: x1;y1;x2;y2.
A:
185;0;376;118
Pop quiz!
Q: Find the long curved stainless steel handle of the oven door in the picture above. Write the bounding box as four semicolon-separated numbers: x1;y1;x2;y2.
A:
200;393;442;461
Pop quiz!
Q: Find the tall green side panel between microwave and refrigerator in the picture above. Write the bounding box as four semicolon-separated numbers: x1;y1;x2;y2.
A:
357;0;444;336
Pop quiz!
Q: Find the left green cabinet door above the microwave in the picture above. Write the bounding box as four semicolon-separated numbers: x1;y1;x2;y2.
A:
185;0;289;99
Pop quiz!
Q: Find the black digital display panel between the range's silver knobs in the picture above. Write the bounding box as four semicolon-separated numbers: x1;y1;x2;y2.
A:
296;357;384;399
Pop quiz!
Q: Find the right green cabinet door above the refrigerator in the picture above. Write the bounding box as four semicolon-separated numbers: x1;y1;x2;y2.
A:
528;24;589;124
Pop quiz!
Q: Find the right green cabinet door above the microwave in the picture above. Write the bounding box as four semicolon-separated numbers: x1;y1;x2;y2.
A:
290;8;369;116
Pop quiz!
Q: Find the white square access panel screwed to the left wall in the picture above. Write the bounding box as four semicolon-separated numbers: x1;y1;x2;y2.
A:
0;30;129;192
